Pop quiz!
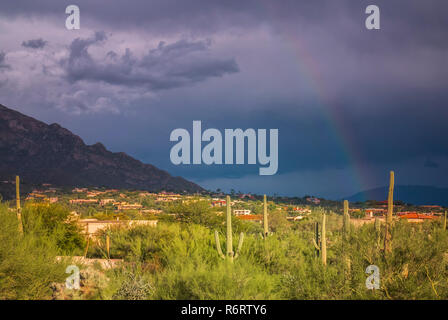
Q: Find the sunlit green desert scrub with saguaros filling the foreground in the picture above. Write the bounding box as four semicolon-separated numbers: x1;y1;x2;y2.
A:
0;174;448;299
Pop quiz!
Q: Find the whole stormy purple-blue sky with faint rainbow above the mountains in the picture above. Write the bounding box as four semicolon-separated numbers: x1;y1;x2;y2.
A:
0;0;448;199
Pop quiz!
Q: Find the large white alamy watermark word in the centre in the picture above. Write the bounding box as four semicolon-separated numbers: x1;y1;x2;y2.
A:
170;121;278;176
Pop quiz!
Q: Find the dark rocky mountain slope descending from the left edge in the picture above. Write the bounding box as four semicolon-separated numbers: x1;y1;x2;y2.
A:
0;105;203;198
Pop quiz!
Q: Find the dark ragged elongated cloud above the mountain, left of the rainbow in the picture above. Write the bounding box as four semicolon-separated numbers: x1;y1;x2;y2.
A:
63;32;239;91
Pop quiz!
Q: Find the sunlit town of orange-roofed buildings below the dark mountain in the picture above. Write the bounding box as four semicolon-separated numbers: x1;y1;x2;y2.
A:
3;181;446;234
